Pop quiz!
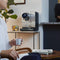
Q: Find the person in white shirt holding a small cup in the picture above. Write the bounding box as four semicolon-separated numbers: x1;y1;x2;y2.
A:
0;0;22;60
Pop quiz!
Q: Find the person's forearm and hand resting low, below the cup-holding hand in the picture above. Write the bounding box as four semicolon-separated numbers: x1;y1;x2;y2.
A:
1;50;19;60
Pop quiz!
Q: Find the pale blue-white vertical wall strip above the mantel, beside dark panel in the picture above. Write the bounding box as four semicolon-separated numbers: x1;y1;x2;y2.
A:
41;0;49;22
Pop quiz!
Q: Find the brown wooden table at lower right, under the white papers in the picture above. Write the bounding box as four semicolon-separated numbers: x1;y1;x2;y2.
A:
41;51;60;60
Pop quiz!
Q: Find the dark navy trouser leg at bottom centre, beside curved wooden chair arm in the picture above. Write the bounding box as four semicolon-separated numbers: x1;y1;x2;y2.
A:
21;53;41;60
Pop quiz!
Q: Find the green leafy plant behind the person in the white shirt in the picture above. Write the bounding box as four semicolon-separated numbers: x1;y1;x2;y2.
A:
0;0;17;21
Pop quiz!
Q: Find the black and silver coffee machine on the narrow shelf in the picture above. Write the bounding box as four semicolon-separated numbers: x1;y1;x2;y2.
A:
20;12;39;31
